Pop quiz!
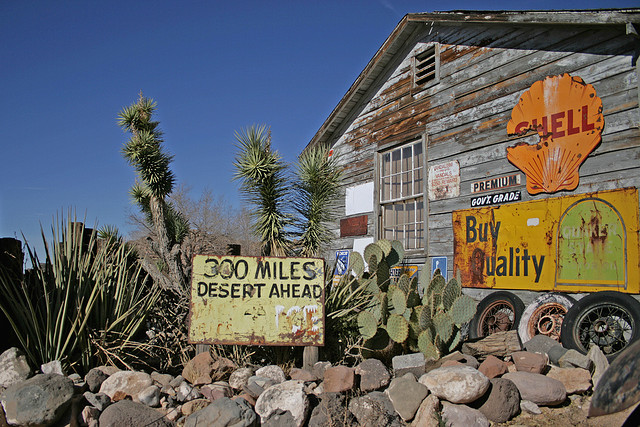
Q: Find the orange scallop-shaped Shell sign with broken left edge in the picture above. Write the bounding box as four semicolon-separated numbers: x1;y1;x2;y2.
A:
507;74;604;194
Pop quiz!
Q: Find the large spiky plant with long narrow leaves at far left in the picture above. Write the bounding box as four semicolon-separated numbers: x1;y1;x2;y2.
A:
0;219;159;372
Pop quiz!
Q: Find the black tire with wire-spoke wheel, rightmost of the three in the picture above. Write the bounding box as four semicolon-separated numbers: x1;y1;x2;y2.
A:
561;291;640;361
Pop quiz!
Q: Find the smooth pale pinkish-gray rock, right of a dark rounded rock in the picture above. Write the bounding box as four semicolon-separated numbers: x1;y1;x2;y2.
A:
502;372;567;405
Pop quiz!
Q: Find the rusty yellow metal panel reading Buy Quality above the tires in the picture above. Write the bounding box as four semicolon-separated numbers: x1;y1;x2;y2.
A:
453;188;640;293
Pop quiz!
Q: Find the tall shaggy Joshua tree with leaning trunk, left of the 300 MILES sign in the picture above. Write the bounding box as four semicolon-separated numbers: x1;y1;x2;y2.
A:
118;93;189;294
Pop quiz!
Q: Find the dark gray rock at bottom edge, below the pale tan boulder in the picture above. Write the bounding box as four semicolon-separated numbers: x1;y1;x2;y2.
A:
99;399;175;427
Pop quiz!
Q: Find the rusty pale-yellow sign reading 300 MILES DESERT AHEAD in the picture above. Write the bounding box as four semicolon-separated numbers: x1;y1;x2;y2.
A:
189;255;325;346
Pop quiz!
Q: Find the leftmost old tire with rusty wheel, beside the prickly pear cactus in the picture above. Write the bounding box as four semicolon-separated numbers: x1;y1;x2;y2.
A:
469;291;524;339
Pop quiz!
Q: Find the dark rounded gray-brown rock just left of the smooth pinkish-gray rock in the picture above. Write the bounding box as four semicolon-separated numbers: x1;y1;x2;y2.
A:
470;378;520;423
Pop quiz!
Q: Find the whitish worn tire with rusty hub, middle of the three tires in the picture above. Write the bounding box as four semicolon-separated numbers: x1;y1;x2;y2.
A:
518;293;576;343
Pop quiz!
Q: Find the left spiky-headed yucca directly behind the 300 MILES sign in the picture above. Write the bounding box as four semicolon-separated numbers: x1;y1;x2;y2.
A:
233;126;291;256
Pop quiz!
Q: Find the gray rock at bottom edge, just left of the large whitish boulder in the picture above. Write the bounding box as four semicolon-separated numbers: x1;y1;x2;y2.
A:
184;397;257;427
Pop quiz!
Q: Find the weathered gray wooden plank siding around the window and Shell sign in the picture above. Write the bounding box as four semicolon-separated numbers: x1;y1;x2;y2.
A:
324;24;640;280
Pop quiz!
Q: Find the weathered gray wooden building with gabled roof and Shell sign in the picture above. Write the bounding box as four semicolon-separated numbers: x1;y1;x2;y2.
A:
309;9;640;354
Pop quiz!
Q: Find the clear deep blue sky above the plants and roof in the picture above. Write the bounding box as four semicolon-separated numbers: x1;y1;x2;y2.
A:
0;0;640;258
